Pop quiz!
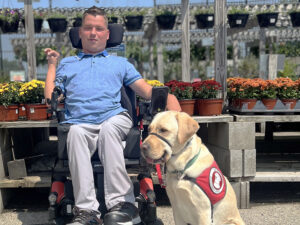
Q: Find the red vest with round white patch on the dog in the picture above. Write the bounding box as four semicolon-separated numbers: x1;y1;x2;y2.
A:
185;161;226;205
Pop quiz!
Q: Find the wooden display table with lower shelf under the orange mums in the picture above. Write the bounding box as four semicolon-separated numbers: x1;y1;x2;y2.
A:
234;115;300;182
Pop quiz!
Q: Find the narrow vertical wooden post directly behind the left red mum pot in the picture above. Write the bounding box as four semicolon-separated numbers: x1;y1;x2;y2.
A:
181;0;191;82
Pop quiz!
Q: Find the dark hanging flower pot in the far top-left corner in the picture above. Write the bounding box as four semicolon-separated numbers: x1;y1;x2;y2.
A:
0;8;21;33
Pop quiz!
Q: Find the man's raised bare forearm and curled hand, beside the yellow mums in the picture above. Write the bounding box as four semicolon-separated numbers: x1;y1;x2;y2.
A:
44;48;60;102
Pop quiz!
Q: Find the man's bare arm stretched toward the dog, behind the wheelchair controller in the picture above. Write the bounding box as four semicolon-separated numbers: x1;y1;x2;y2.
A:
129;79;181;112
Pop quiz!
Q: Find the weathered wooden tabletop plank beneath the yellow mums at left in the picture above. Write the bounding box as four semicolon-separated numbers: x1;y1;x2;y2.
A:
0;120;57;128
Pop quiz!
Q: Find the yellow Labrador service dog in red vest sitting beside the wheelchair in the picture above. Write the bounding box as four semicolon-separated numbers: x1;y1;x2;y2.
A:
141;111;245;225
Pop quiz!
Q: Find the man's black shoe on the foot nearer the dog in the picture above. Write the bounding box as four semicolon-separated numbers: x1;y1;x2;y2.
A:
104;202;142;225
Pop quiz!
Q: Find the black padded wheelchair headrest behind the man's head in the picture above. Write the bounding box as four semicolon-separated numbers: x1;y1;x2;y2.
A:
69;23;124;49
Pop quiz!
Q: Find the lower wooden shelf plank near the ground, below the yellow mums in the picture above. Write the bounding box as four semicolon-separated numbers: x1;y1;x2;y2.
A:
0;176;51;188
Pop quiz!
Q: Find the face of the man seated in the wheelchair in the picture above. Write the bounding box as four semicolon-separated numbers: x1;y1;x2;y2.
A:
79;14;109;54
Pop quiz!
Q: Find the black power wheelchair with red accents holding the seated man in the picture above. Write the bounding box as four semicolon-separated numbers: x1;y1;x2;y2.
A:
48;24;168;225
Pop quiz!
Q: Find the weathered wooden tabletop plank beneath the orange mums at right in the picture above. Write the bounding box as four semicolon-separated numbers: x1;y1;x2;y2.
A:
233;115;300;123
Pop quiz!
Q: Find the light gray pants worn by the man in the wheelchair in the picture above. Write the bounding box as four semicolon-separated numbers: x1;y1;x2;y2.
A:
67;115;135;211
